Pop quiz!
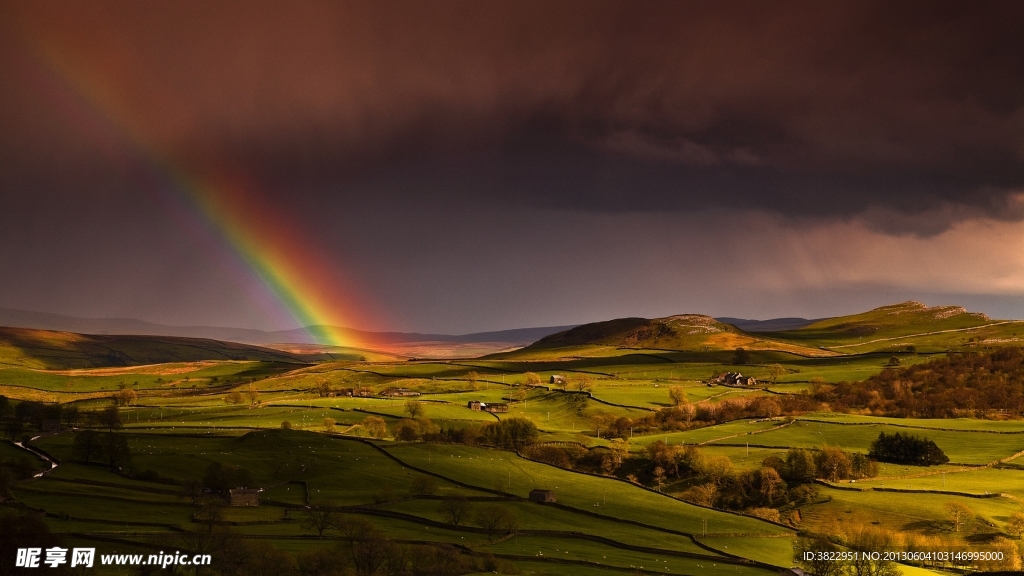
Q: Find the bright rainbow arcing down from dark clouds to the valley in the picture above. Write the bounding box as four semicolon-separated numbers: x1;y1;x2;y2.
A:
9;36;369;347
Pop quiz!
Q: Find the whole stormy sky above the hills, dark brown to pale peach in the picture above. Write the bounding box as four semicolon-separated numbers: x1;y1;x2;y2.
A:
0;0;1024;333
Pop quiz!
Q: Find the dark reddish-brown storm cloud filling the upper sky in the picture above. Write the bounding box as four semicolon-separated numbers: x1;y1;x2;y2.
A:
0;2;1024;232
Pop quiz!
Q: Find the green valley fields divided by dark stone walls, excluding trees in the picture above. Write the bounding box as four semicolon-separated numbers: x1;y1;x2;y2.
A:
6;306;1024;575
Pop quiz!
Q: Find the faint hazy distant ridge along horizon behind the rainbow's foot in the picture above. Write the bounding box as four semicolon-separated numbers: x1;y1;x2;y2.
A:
0;308;573;346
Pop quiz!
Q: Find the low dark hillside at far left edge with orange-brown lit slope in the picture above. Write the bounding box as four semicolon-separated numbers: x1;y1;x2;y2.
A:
0;327;304;369
